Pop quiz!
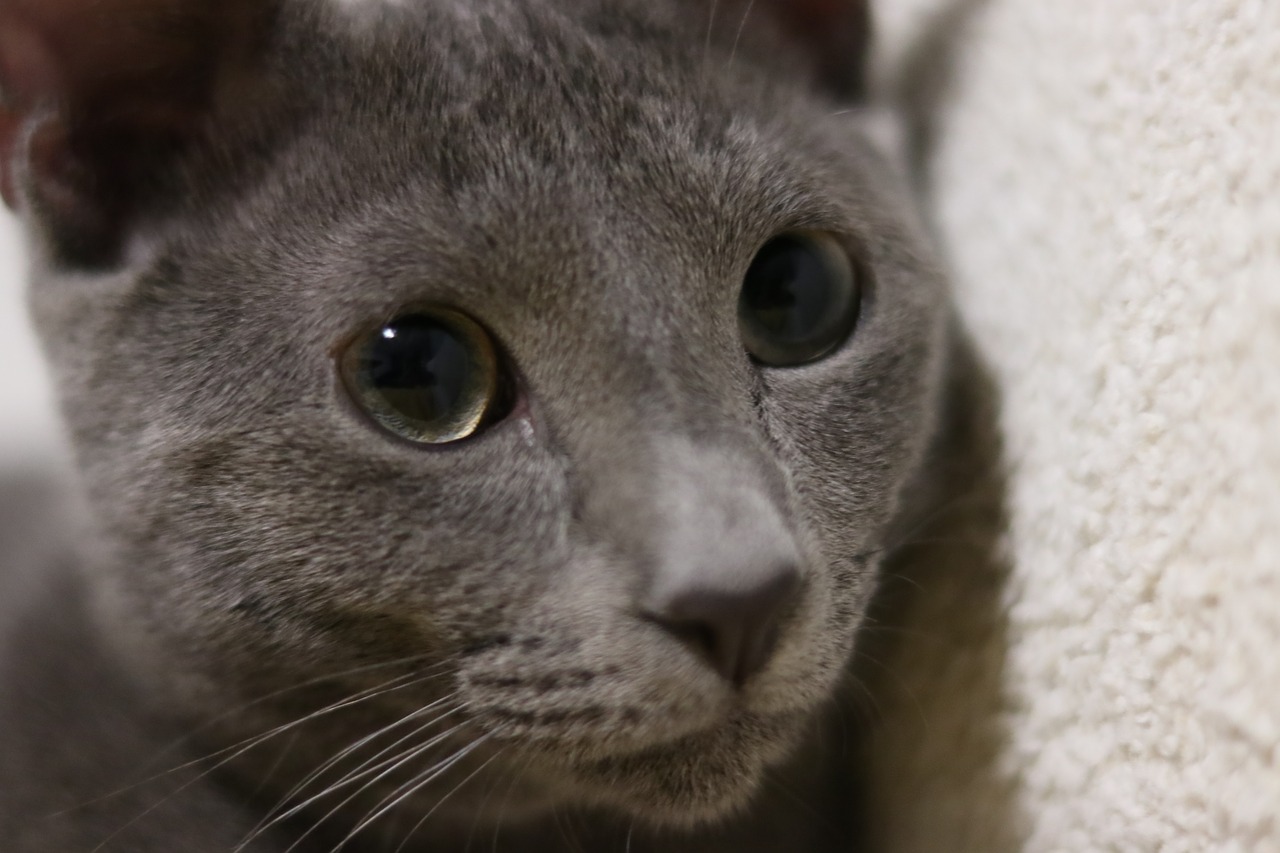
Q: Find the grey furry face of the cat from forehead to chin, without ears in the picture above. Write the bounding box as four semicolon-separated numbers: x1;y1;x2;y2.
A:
5;0;943;824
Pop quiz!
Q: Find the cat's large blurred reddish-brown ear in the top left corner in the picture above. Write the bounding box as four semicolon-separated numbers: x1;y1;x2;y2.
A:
0;0;271;264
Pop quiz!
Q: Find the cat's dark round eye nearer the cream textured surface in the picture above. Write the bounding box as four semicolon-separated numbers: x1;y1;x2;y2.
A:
737;231;861;368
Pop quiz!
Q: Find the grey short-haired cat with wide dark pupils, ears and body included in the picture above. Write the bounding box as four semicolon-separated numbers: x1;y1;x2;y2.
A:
0;0;988;853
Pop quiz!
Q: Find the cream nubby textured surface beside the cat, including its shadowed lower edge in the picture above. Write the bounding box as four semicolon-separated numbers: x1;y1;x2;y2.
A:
873;0;1280;853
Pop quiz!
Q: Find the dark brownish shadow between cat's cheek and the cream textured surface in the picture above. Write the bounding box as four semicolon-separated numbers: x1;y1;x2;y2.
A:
844;324;1023;853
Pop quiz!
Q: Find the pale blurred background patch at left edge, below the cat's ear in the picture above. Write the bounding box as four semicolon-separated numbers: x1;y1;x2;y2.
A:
0;207;61;469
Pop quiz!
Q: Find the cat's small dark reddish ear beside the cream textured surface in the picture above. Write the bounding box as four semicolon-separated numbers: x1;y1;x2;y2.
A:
721;0;872;99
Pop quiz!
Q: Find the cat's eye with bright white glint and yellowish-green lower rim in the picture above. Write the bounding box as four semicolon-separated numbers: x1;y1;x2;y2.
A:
339;309;500;444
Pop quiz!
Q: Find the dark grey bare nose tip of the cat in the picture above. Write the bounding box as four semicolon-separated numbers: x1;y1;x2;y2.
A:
648;564;800;686
